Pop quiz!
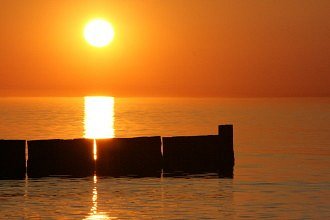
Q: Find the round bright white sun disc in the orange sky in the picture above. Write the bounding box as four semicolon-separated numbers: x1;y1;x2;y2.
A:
84;19;115;47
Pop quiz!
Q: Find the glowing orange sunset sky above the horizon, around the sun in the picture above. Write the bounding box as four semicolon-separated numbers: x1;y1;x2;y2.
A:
0;0;330;97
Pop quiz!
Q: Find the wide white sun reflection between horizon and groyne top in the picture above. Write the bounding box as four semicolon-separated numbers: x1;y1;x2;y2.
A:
84;96;115;139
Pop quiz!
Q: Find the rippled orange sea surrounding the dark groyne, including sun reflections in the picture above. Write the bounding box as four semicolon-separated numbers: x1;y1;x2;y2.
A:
0;97;330;219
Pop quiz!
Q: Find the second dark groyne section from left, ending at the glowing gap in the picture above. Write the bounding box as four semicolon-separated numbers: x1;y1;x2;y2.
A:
28;139;94;177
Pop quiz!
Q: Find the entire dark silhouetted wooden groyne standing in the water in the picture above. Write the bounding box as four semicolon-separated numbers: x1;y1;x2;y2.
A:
0;125;234;179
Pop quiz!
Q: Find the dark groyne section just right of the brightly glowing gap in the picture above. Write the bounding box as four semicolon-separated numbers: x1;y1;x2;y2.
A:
96;137;162;177
